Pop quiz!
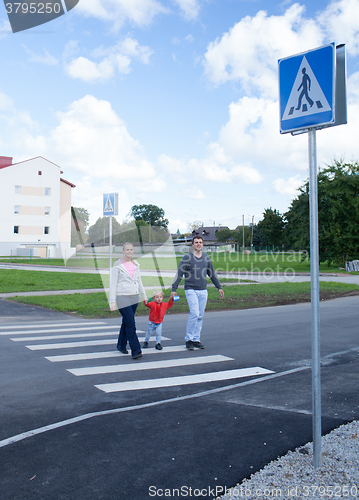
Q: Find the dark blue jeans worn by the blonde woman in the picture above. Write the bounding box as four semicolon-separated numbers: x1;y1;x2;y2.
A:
117;295;141;356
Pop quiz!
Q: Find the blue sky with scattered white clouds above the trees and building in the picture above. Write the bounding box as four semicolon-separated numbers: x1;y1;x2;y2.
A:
0;0;359;232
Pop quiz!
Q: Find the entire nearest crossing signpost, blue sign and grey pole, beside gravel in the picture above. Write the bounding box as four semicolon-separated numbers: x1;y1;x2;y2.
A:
278;43;347;467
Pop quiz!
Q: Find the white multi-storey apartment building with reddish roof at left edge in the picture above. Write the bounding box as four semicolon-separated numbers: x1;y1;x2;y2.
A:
0;156;75;259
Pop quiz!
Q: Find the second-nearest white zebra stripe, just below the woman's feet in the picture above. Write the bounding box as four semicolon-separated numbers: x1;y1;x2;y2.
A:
67;354;233;377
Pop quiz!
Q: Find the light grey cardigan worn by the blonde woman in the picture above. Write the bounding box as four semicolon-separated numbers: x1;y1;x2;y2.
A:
110;259;147;302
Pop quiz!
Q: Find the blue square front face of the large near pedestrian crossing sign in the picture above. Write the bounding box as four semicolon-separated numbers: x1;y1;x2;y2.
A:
278;43;336;134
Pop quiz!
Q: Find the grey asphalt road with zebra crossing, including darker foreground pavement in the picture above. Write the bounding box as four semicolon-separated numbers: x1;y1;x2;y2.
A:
0;297;359;500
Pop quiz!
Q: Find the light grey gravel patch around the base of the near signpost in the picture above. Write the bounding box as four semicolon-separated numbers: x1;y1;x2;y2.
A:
217;421;359;500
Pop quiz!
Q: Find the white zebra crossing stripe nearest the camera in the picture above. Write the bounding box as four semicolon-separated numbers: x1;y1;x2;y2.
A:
95;362;274;393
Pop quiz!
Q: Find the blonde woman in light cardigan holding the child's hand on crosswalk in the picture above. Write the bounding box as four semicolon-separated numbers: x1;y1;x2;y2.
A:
110;243;148;359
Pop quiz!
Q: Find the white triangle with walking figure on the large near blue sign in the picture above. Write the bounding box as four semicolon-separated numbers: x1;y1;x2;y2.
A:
282;56;331;121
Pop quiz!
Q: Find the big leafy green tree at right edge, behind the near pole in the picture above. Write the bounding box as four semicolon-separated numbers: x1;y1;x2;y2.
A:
285;160;359;264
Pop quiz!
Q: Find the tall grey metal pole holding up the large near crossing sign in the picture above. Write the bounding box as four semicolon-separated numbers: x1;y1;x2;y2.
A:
308;128;322;467
